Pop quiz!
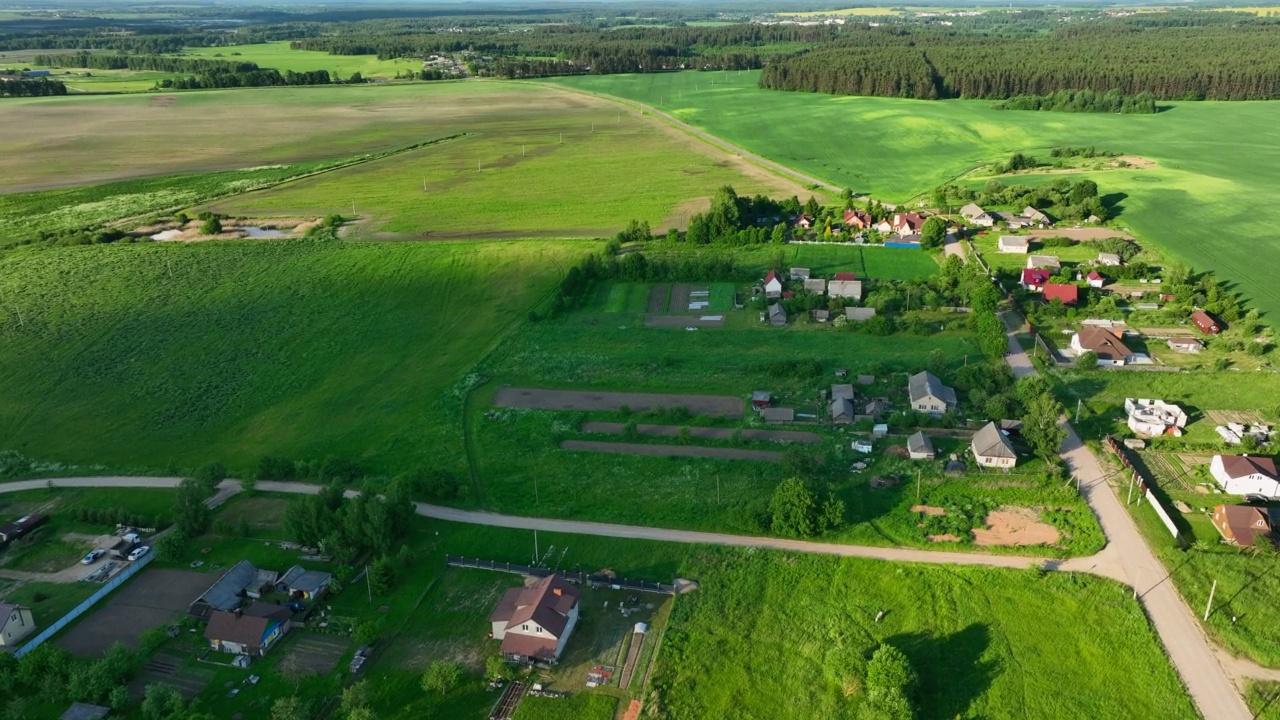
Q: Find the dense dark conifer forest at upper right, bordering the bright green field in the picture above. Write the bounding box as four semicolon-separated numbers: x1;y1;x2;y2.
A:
760;24;1280;100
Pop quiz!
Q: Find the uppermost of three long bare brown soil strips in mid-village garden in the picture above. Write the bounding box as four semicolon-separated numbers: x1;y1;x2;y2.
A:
493;387;744;418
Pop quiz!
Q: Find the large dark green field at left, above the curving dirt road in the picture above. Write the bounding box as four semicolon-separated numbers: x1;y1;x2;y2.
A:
0;241;591;471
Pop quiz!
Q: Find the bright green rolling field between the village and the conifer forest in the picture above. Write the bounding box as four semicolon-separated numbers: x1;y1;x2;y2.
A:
556;72;1280;315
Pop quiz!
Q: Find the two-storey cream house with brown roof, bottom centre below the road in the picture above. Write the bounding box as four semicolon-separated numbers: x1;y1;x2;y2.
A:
489;574;581;665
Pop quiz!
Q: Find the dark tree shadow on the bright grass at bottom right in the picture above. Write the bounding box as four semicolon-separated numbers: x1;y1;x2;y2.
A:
884;623;1000;720
